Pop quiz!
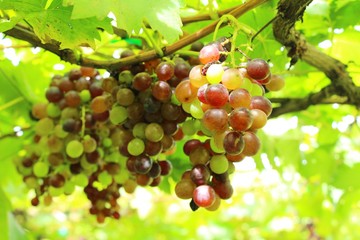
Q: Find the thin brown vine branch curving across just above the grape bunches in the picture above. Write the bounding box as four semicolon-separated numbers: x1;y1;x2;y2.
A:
5;0;268;70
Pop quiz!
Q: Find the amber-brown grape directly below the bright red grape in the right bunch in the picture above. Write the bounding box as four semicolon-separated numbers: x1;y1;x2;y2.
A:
202;108;228;133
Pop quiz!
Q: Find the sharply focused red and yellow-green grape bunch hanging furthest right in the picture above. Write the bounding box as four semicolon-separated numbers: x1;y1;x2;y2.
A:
175;39;283;210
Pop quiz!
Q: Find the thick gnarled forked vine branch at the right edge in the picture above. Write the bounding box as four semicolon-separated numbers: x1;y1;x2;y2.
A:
271;0;360;117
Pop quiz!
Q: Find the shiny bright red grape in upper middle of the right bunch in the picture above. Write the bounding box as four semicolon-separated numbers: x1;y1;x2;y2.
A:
205;84;229;107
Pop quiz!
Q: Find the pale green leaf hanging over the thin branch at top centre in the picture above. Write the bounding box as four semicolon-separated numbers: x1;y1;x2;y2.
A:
112;0;182;42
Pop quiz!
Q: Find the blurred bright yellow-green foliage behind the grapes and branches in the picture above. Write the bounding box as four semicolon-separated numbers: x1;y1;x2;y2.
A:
0;0;360;240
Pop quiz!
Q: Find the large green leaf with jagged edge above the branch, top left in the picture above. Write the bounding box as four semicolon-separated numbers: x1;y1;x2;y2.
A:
1;0;112;49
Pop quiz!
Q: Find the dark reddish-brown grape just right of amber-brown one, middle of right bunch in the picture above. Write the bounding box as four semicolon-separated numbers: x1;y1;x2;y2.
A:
229;107;254;131
